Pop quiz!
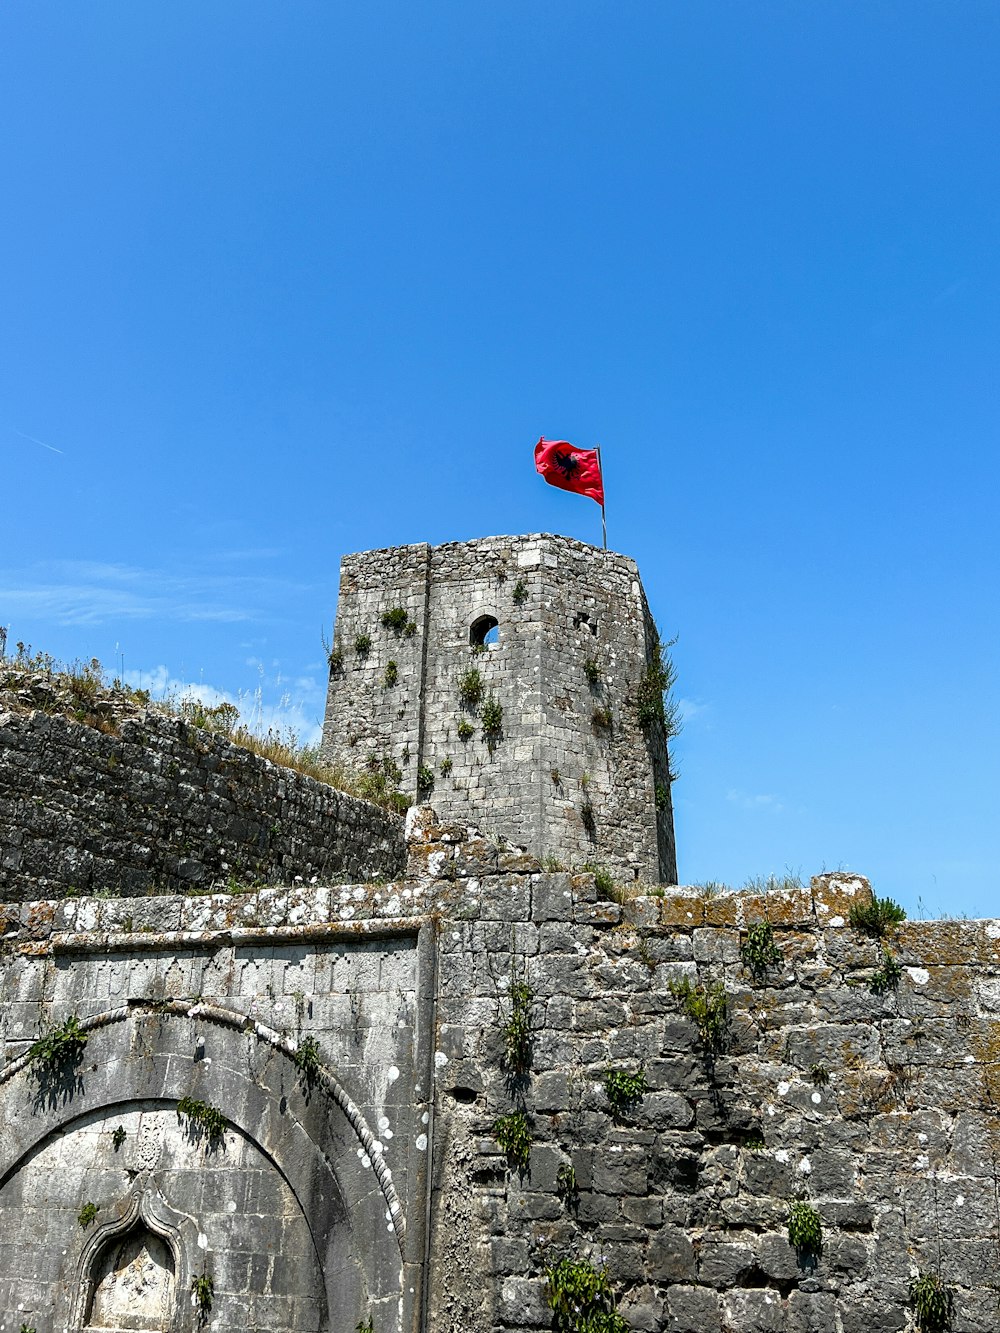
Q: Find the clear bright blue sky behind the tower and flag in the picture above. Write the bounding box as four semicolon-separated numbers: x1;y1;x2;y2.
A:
0;0;1000;914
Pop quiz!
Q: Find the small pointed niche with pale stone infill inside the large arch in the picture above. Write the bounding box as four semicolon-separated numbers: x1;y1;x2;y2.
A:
85;1226;176;1333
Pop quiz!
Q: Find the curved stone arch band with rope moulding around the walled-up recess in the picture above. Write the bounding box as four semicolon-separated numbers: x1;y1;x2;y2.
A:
0;1001;409;1330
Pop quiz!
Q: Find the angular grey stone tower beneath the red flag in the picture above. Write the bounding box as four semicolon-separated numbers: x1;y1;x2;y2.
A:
323;535;677;884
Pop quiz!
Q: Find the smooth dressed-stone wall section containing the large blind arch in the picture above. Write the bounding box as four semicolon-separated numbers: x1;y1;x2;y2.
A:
0;888;433;1333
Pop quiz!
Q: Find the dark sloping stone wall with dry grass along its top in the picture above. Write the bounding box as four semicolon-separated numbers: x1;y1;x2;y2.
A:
0;701;405;898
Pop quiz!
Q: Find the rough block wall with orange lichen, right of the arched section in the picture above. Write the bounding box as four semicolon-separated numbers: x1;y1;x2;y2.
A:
411;810;1000;1333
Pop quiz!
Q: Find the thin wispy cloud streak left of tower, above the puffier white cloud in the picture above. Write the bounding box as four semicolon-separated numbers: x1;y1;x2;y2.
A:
0;560;309;625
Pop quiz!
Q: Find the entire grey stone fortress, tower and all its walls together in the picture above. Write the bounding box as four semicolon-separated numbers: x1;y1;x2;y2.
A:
0;537;1000;1333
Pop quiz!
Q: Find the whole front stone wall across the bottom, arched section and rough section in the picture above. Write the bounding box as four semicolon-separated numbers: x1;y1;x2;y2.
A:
0;809;1000;1333
